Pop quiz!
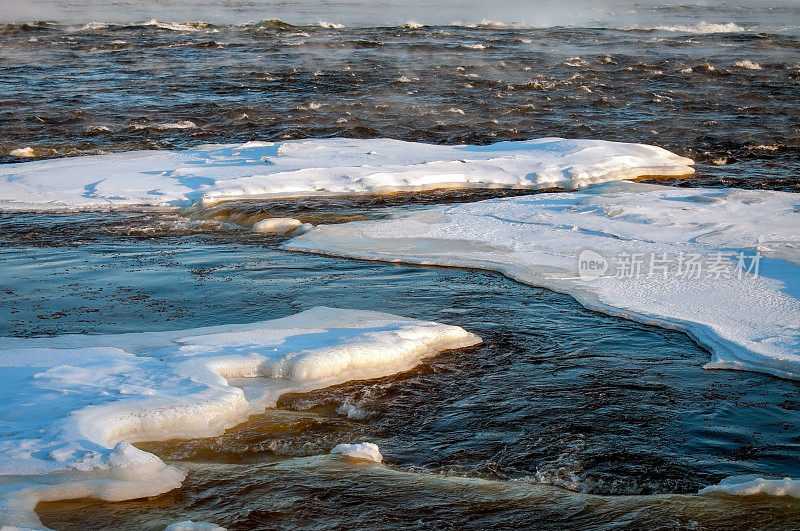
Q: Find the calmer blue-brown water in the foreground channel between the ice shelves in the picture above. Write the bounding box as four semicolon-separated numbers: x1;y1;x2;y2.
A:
0;207;800;529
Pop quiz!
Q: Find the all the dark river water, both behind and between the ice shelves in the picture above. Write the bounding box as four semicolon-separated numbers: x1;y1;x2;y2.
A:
0;0;800;529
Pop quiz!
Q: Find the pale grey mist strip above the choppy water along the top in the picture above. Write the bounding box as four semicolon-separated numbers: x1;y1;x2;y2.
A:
0;0;797;26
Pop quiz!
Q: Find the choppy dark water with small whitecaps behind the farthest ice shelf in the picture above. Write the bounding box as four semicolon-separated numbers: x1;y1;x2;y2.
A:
0;2;800;190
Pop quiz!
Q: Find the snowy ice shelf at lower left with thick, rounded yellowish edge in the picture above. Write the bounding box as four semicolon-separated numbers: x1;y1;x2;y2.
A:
0;307;480;527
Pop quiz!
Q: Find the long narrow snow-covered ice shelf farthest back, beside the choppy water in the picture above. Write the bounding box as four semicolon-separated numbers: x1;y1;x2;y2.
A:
0;138;694;211
